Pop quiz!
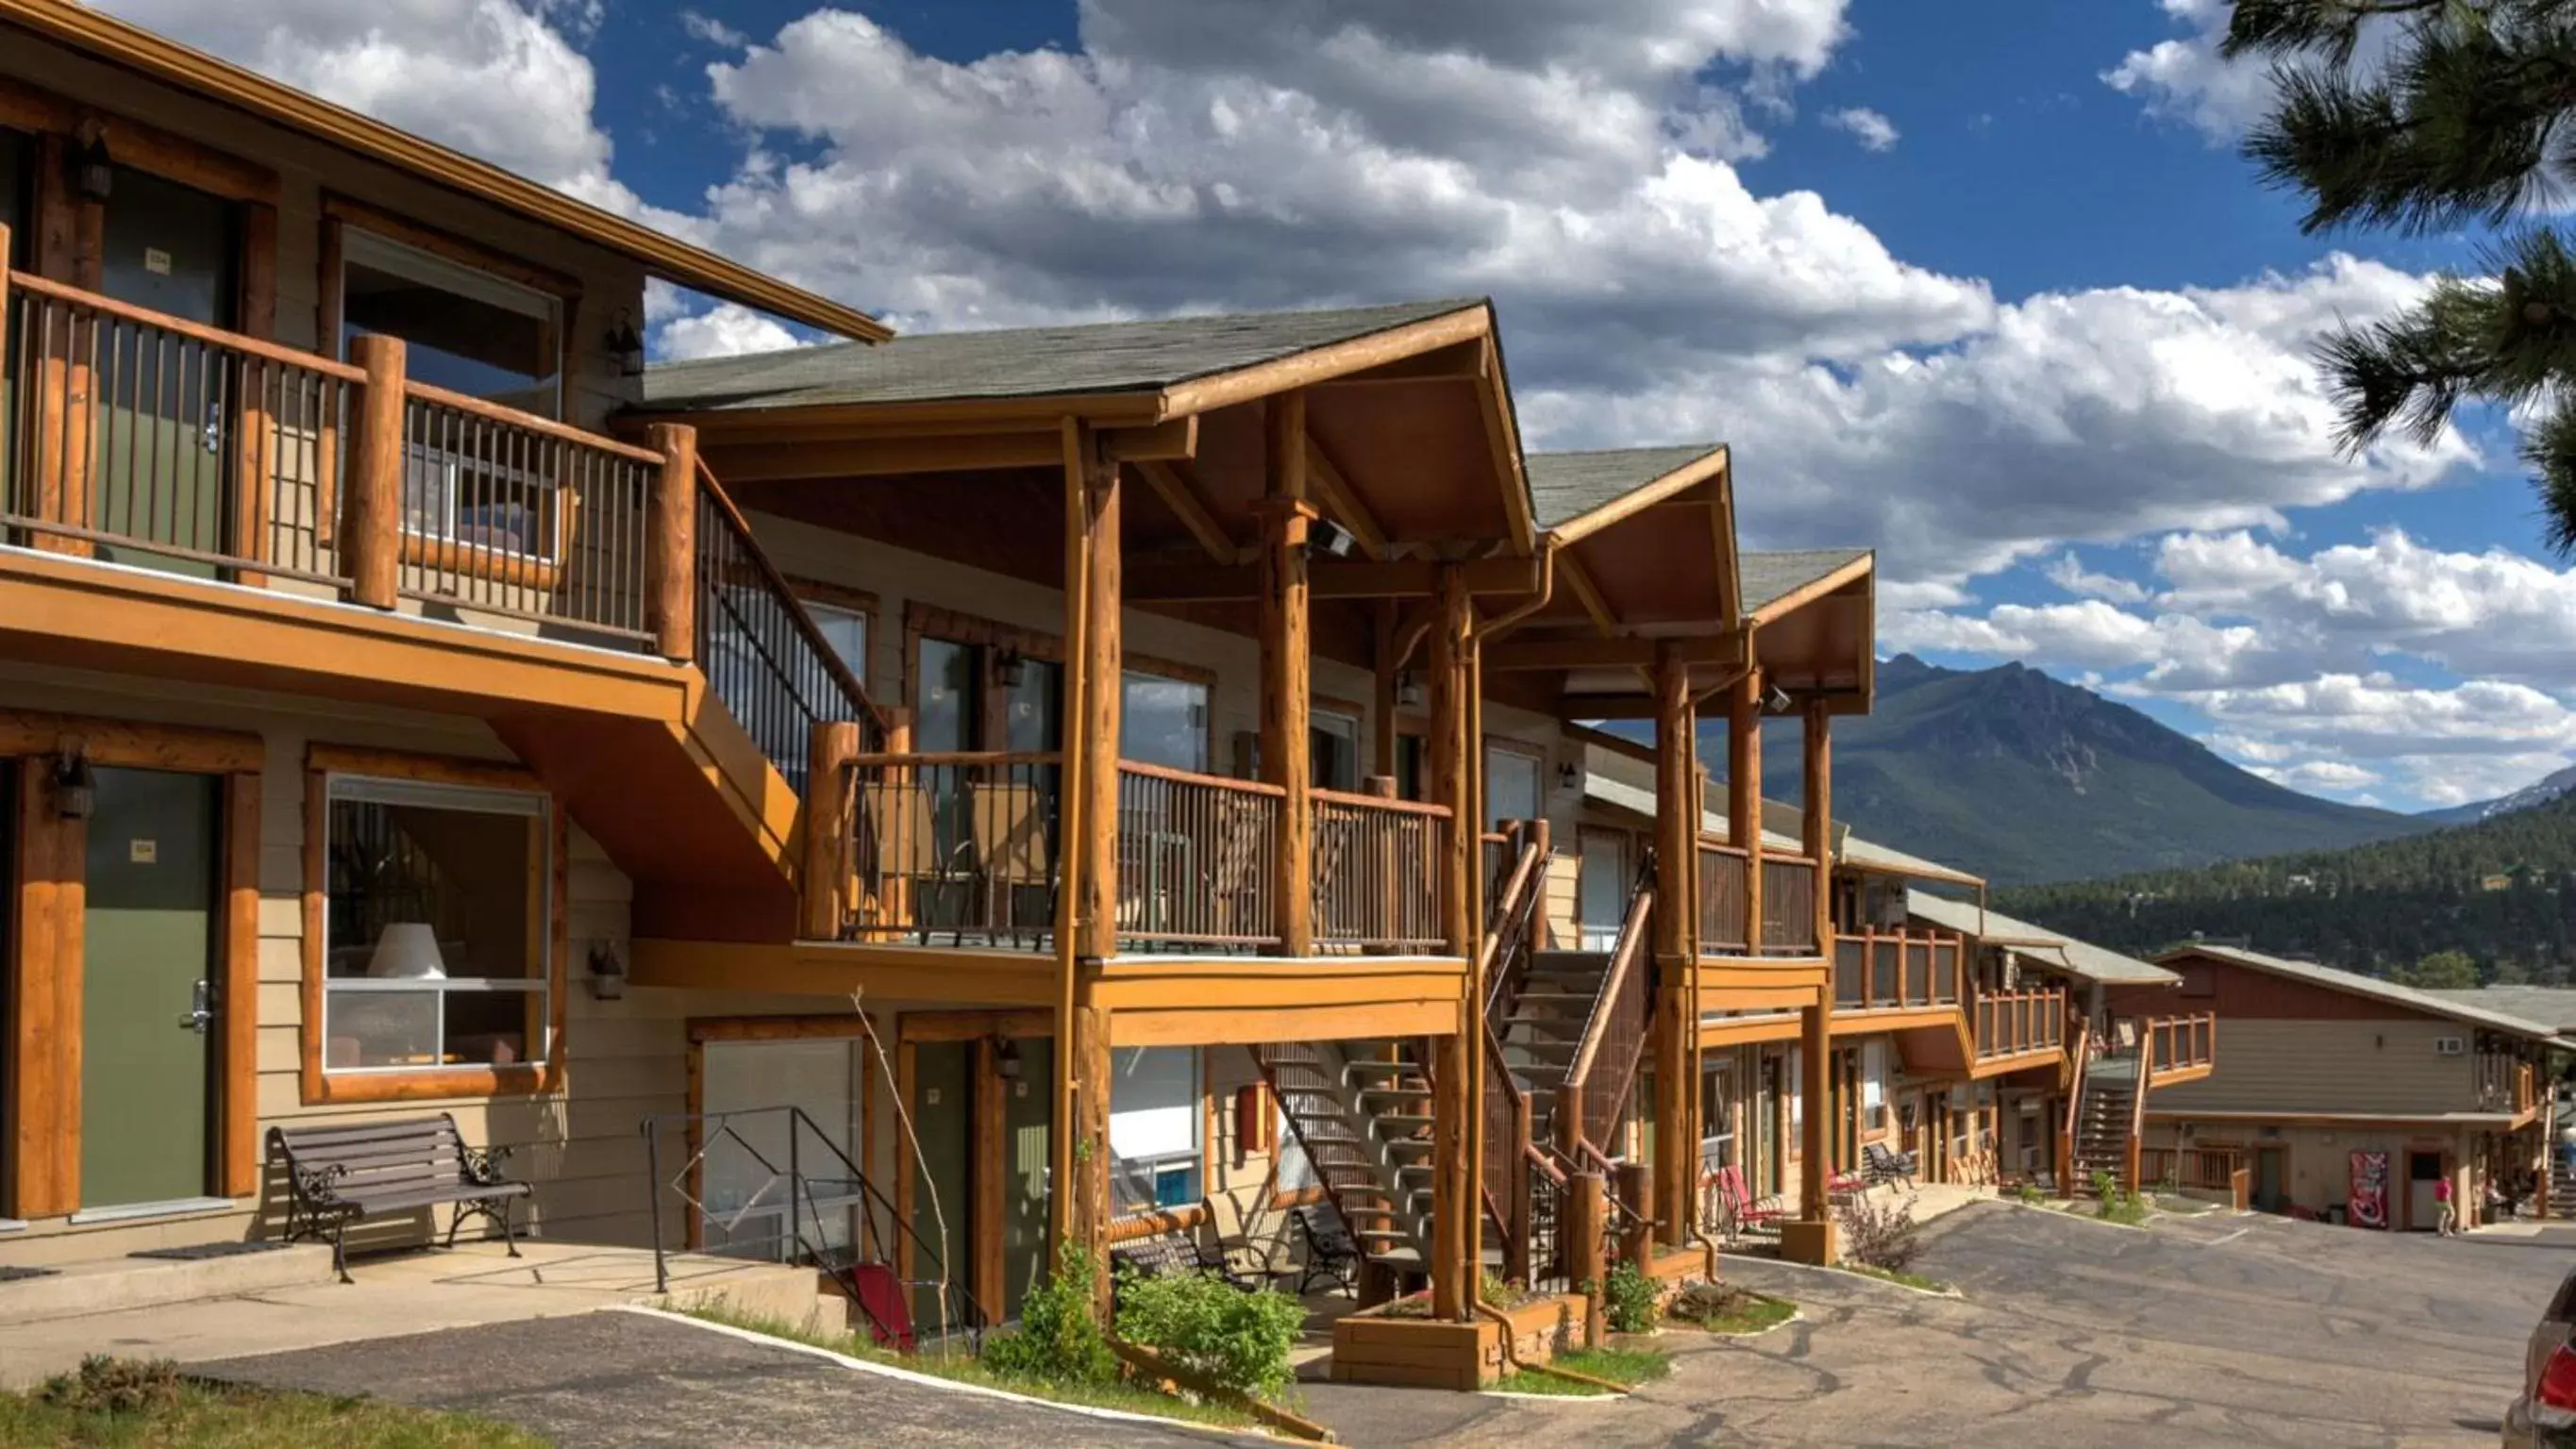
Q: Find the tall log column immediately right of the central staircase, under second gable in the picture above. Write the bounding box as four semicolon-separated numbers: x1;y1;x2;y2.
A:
1651;643;1700;1245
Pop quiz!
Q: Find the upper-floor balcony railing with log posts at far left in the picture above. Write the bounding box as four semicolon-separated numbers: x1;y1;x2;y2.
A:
0;265;691;657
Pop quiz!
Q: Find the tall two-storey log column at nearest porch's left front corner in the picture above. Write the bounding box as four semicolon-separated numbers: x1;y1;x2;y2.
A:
1048;420;1123;1312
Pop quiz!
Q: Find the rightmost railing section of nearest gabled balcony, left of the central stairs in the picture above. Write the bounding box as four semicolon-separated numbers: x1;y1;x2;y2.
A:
1312;791;1450;952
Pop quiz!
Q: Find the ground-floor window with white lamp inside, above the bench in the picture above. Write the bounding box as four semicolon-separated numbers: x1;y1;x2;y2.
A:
322;774;554;1074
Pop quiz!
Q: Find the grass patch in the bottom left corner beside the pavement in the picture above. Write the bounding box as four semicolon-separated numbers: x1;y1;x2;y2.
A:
0;1359;546;1449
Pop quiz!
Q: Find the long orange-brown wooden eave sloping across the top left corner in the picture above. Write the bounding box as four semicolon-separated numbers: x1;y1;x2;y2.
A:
0;0;894;342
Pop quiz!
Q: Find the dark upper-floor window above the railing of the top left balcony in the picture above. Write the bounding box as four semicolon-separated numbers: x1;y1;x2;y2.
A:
340;226;564;417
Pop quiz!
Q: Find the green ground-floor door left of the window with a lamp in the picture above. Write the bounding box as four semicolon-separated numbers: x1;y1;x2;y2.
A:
80;770;216;1208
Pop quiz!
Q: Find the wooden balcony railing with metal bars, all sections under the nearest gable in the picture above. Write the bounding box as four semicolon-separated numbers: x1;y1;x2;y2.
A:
814;752;1450;958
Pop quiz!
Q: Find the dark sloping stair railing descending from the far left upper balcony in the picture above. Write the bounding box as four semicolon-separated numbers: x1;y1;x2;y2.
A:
695;458;889;795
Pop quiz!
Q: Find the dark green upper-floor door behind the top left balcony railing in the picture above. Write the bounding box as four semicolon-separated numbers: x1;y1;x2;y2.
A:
91;167;240;576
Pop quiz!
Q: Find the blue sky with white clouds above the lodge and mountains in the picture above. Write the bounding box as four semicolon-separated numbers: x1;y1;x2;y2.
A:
103;0;2576;810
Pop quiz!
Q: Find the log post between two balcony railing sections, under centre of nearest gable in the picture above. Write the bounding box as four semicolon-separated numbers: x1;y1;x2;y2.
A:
1260;391;1316;955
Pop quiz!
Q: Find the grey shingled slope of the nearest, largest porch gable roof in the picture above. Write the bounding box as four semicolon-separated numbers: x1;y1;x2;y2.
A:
644;298;1483;409
